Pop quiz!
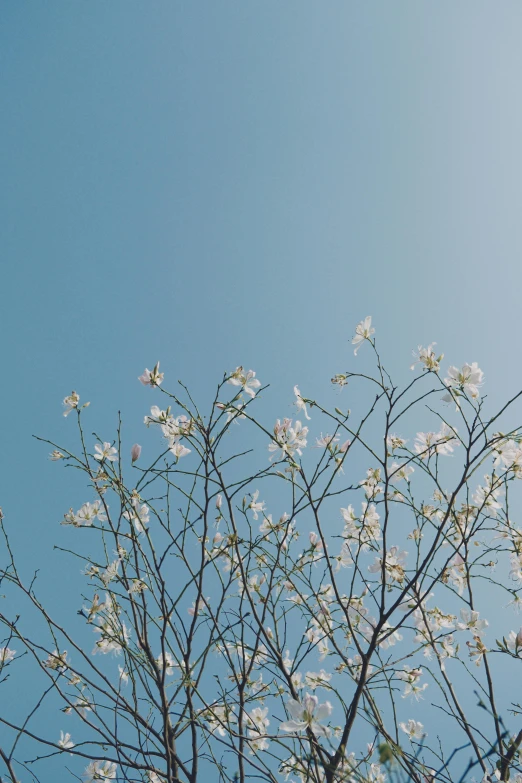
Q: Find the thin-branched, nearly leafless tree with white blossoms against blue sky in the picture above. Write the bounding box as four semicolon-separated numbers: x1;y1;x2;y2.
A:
0;317;522;783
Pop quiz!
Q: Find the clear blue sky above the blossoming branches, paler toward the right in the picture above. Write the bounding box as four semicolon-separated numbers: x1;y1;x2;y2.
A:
0;0;522;776
